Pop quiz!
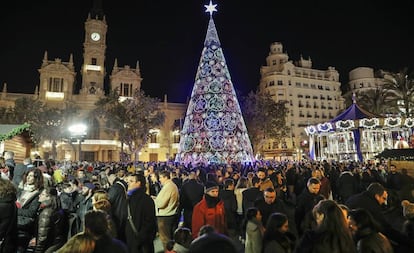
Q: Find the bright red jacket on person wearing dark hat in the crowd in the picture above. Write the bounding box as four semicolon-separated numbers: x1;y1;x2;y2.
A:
191;197;227;239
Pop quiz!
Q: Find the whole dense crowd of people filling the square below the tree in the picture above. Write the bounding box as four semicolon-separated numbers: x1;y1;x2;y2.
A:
0;151;414;253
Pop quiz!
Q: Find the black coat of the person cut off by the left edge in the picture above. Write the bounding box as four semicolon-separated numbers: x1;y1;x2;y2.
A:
0;193;17;253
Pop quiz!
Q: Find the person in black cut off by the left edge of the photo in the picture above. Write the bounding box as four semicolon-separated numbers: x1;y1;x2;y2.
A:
0;178;17;253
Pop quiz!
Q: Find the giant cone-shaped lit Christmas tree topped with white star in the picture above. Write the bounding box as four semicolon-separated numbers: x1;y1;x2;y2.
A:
176;1;254;165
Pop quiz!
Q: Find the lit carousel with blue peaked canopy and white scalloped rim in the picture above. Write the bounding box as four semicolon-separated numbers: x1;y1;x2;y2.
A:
305;100;414;161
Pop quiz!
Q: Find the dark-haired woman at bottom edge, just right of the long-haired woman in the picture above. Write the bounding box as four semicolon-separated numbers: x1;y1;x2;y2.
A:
349;208;394;253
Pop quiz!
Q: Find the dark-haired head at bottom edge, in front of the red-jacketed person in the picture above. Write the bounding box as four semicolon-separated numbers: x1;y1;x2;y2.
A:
189;231;238;253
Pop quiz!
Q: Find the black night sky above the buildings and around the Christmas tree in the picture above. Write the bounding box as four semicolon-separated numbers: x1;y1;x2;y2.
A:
0;0;414;102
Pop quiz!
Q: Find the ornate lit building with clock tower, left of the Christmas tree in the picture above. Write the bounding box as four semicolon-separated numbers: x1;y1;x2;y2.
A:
0;3;187;161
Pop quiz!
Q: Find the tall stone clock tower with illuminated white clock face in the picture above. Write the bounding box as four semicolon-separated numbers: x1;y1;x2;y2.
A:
80;0;108;95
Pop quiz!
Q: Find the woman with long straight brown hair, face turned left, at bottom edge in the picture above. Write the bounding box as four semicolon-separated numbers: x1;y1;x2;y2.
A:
295;200;356;253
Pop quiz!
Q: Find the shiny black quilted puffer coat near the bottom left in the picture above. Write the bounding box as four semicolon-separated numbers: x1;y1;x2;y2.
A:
35;207;68;253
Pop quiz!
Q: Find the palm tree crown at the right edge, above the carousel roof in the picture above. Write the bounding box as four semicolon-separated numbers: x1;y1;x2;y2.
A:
383;68;414;117
